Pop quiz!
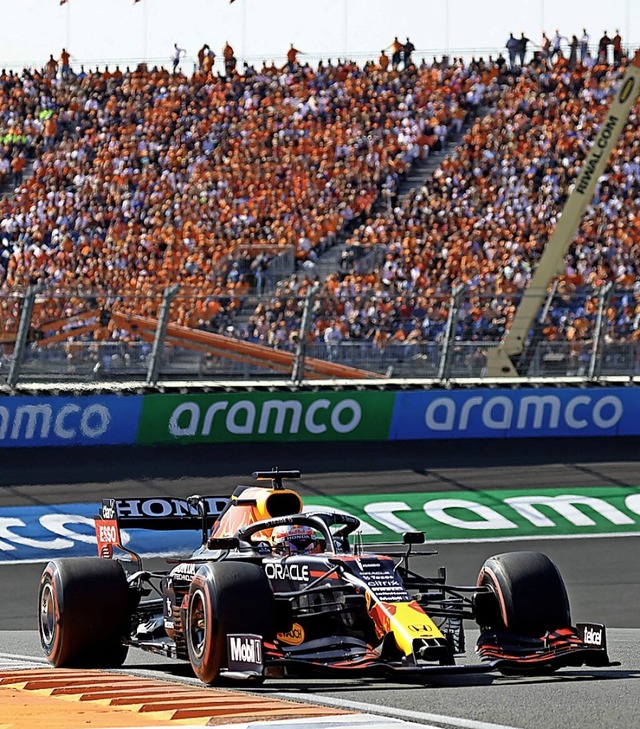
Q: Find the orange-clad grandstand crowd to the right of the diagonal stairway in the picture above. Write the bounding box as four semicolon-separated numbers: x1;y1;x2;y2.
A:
241;60;640;345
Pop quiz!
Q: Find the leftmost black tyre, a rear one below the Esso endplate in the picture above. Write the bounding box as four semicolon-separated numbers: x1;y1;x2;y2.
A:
38;557;130;668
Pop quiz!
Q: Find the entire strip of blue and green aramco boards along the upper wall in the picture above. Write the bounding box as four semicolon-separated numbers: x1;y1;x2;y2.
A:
0;387;640;448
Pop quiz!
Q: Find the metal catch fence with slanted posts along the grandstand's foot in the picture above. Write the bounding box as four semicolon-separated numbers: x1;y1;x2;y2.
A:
0;284;640;388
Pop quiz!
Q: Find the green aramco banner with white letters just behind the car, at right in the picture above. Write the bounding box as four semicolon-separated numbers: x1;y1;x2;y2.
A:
305;486;640;542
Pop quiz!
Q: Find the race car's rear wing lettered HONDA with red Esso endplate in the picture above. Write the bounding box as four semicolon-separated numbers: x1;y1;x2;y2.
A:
95;496;229;559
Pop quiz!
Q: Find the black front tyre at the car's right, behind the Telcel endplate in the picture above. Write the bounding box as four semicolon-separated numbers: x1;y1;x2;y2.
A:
476;552;571;637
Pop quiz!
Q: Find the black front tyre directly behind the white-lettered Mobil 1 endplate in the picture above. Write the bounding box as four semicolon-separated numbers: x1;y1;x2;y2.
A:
184;562;276;684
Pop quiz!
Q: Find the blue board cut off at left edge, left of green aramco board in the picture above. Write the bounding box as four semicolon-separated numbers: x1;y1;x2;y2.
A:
0;395;142;448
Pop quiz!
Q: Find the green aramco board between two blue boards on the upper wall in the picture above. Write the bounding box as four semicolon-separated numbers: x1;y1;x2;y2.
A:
137;391;395;445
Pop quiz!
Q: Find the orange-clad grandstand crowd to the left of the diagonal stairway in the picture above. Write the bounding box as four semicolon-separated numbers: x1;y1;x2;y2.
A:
0;57;474;344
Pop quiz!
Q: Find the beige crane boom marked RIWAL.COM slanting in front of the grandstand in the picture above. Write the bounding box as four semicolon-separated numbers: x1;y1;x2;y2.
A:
487;51;640;377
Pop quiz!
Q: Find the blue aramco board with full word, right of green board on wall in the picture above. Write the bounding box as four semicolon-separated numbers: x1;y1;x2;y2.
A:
389;387;640;440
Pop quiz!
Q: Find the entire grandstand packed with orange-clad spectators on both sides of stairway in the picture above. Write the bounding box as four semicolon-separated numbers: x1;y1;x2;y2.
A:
0;50;640;376
